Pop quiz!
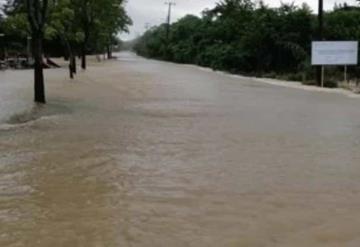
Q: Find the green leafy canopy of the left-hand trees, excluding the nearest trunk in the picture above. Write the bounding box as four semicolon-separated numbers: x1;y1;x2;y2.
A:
0;0;131;63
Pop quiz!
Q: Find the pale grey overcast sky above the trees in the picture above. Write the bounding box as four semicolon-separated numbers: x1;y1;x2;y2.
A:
120;0;356;40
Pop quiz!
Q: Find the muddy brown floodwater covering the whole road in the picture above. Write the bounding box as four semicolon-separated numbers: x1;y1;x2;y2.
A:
0;53;360;247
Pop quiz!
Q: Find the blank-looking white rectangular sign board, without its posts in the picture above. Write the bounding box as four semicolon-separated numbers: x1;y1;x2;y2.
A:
311;41;358;65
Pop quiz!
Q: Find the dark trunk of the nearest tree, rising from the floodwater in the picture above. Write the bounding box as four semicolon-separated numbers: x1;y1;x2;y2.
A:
32;32;46;104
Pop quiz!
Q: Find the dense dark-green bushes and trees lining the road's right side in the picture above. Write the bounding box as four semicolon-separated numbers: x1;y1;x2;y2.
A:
135;0;360;83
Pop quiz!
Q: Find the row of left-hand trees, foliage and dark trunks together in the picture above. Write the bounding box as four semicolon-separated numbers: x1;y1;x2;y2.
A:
0;0;131;103
